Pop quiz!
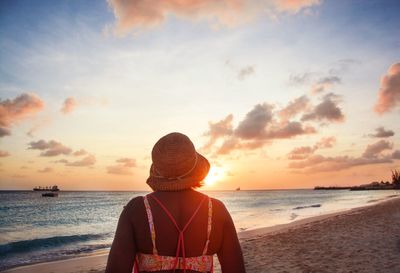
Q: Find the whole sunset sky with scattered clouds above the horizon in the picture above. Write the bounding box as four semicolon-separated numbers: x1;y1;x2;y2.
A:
0;0;400;190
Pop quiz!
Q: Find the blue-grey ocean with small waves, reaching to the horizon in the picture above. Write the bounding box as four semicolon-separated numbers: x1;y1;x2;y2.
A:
0;190;400;270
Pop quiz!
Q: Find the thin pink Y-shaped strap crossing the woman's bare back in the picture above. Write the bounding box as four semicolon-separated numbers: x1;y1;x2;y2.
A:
149;194;207;273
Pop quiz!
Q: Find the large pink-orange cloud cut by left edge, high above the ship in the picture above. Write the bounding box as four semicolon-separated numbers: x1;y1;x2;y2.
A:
0;93;44;137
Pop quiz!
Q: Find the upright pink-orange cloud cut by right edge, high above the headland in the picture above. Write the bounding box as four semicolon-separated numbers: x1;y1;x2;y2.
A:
374;63;400;114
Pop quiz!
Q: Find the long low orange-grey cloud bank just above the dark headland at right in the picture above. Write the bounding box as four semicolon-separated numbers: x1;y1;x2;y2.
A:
288;140;400;173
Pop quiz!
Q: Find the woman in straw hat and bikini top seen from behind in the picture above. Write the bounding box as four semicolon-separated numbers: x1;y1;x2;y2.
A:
106;133;245;273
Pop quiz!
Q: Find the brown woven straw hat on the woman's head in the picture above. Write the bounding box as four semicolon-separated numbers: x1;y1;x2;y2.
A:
147;133;210;191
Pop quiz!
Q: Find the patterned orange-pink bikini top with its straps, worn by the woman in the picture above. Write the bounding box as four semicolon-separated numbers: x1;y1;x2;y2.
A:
134;194;213;273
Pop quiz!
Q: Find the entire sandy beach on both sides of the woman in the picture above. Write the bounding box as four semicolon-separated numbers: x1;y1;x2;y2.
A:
5;197;400;273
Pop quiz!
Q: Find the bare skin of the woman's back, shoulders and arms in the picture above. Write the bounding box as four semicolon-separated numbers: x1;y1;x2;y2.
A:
106;190;245;273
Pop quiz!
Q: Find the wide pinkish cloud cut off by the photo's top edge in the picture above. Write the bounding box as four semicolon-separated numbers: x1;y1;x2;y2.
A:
108;0;320;35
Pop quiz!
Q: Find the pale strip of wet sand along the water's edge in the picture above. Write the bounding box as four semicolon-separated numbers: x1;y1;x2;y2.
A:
1;195;400;273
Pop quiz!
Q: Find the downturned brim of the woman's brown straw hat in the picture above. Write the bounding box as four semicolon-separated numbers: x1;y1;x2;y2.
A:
146;153;210;191
